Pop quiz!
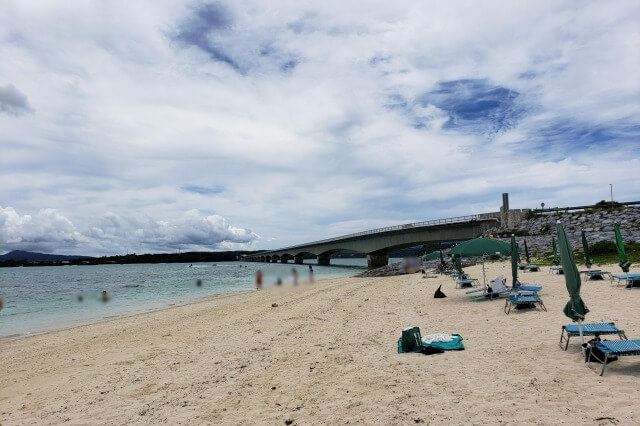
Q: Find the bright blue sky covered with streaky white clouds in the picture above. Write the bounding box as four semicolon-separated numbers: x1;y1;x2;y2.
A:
0;0;640;255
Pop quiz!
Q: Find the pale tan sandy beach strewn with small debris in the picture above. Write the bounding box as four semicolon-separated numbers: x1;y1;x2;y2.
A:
0;262;640;425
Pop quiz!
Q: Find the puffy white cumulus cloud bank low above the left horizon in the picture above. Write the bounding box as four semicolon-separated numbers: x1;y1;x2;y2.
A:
0;207;259;254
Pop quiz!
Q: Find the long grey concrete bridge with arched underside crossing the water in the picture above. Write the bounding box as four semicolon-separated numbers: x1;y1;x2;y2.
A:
242;212;504;268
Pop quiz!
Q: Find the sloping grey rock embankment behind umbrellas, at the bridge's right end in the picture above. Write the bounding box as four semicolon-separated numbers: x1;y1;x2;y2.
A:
486;207;640;253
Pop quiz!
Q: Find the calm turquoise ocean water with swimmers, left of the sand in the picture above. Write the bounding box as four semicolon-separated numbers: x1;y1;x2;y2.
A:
0;259;397;337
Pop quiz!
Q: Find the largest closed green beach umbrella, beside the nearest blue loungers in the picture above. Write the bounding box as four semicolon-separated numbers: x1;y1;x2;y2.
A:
557;221;589;350
